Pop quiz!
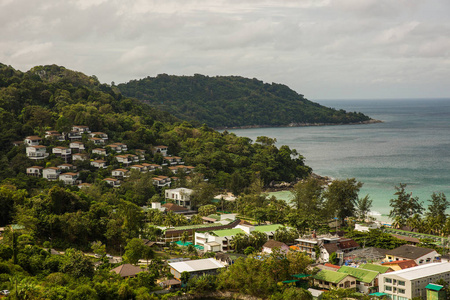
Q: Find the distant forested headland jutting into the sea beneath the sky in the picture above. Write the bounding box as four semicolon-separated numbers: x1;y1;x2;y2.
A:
118;74;370;128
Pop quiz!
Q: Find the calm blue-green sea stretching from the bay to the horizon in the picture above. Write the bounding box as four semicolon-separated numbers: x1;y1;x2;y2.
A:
228;98;450;222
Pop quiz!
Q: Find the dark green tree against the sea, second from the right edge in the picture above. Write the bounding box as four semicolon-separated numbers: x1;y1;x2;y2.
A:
389;183;423;226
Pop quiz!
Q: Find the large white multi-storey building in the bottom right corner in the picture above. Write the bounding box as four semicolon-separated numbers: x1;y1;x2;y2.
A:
379;263;450;300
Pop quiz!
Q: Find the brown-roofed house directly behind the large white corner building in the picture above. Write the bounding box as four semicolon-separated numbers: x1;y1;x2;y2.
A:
386;245;439;265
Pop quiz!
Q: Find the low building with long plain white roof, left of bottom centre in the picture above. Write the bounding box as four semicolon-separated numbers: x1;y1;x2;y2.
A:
169;258;224;280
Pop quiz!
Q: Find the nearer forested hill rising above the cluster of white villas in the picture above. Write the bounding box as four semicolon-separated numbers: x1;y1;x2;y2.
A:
0;64;311;190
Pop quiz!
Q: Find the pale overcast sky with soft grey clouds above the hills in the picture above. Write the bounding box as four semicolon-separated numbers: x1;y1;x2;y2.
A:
0;0;450;101
